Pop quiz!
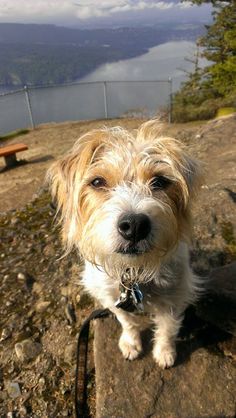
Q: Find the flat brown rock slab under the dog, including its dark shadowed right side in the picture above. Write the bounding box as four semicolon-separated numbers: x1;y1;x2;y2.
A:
95;263;236;418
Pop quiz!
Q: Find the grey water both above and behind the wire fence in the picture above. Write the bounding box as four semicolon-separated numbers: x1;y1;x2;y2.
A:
0;41;207;135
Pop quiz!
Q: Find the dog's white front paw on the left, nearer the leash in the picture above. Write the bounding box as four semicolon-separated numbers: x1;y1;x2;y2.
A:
119;332;142;360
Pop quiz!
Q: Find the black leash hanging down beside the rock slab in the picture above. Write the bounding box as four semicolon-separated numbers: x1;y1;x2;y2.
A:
75;309;111;418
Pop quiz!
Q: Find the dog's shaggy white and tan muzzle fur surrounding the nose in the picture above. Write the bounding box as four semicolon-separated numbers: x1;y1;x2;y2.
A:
79;187;178;282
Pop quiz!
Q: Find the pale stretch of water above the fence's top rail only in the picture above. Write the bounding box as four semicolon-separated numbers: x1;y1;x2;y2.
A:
80;41;207;91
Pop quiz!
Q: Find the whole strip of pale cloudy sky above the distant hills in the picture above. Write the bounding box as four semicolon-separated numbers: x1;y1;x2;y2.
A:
0;0;209;26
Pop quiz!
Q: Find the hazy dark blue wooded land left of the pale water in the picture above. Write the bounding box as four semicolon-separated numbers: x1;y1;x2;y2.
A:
0;23;204;88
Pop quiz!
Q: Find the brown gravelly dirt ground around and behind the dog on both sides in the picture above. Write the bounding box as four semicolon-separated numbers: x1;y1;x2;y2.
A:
0;116;236;418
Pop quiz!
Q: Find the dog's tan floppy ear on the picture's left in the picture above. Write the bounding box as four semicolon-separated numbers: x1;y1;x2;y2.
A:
46;131;102;250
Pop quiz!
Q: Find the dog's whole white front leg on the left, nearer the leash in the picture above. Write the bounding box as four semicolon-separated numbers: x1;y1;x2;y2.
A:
112;308;142;360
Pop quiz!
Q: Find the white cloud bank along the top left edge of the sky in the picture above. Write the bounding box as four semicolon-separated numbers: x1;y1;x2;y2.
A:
0;0;188;21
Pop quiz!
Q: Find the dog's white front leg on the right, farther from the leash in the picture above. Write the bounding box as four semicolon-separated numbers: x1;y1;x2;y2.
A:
153;312;182;369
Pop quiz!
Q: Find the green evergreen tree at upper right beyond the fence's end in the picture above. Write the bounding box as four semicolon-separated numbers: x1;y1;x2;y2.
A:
175;0;236;121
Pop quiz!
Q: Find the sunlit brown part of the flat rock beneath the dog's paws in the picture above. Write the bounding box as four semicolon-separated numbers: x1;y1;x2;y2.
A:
95;318;236;418
